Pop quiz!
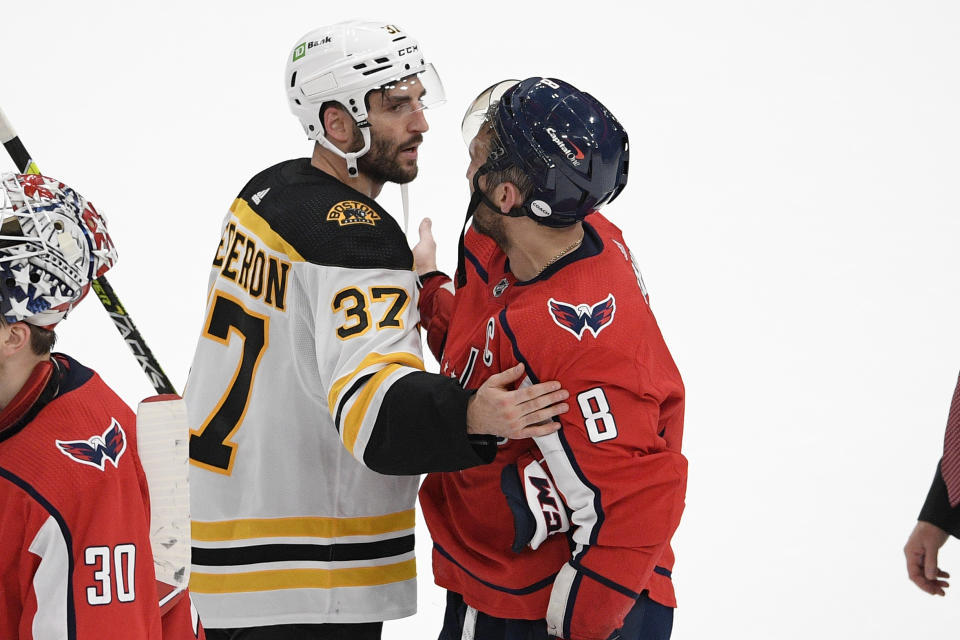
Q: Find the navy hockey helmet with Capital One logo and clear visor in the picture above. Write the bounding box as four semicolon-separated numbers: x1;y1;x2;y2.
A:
463;77;629;227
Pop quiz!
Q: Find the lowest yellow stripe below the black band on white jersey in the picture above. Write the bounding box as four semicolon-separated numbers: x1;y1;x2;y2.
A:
190;558;417;593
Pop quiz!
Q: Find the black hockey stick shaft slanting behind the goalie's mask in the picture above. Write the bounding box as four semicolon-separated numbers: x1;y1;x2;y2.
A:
0;109;176;394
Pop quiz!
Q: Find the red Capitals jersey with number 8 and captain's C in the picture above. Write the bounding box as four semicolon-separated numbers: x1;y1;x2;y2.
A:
419;214;686;639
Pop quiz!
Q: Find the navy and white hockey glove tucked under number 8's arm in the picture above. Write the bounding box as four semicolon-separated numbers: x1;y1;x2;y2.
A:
500;449;570;553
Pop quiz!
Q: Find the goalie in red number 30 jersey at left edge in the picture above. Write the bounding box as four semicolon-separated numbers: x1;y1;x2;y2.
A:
0;174;204;640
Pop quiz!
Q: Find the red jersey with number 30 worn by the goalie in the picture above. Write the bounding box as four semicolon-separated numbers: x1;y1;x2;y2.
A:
0;355;203;640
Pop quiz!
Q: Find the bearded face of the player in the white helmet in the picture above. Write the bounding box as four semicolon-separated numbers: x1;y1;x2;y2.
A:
354;82;429;184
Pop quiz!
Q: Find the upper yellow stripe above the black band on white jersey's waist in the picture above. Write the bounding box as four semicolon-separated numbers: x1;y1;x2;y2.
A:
191;509;416;542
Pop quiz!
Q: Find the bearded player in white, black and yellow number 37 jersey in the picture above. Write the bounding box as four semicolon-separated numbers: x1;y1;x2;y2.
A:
185;22;567;640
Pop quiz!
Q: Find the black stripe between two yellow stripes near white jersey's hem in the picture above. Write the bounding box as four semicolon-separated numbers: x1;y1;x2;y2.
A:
192;534;414;567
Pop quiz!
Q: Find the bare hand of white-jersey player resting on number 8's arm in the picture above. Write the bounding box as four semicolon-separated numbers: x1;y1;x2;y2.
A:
467;364;570;439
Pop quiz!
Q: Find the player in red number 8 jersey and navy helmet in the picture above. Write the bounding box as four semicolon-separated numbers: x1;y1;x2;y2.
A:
414;77;686;640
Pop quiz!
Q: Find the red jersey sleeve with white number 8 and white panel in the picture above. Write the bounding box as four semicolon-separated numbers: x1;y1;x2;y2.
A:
537;342;687;640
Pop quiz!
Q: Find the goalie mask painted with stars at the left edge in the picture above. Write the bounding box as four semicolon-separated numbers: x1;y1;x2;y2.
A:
0;173;117;329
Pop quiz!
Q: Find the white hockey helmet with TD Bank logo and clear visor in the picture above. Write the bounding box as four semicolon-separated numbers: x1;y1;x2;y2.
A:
284;20;445;176
